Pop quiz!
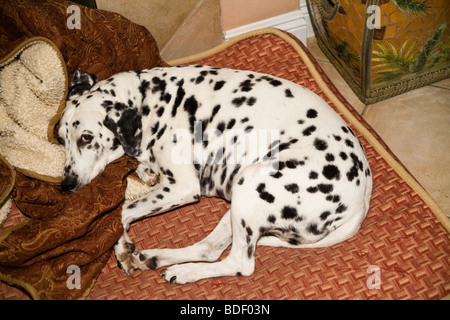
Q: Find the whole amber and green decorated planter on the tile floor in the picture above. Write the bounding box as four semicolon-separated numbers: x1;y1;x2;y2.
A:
307;0;450;103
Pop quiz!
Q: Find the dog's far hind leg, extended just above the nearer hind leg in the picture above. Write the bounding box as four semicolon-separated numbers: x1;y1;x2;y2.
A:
126;210;232;270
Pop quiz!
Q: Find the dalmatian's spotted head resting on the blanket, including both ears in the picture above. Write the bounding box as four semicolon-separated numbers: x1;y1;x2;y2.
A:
58;70;142;191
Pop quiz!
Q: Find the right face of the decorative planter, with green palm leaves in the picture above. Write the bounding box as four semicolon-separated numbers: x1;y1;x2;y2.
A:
371;0;450;86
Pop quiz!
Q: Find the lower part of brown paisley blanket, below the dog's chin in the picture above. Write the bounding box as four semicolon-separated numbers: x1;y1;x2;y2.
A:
0;157;137;299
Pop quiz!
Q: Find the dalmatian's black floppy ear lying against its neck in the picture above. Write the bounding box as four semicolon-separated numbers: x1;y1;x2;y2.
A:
103;108;142;157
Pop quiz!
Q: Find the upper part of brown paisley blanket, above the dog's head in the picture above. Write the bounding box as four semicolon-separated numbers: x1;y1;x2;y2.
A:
0;0;165;84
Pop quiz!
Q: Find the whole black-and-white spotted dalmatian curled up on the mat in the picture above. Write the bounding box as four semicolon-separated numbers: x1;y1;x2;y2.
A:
58;65;372;284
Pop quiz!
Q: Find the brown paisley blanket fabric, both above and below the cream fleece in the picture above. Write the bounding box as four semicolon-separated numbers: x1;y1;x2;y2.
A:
0;0;166;299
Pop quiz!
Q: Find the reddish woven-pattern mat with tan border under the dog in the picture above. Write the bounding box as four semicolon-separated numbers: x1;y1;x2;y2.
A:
0;29;450;300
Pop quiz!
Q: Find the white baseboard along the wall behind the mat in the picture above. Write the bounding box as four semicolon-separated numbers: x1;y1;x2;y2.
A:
223;9;308;46
